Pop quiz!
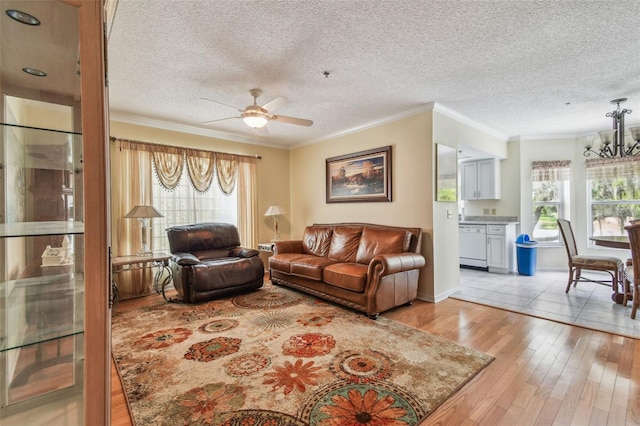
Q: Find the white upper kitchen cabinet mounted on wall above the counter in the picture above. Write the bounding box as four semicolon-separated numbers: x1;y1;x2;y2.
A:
460;158;500;200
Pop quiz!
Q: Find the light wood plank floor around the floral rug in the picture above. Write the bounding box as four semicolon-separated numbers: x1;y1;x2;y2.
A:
111;288;640;426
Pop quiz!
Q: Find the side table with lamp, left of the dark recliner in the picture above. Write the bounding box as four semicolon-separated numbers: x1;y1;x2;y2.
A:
111;253;173;309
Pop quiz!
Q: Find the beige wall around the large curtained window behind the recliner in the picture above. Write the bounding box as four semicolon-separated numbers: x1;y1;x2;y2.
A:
110;121;291;246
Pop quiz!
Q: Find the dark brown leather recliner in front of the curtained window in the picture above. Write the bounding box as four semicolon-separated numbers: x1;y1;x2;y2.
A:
167;223;264;303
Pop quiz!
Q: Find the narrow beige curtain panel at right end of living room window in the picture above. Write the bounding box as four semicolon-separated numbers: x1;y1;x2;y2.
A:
238;158;258;247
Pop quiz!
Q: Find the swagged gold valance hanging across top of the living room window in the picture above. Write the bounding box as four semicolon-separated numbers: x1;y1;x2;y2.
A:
111;137;259;194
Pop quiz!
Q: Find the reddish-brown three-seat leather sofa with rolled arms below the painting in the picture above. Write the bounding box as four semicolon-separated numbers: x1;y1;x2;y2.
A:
269;223;425;319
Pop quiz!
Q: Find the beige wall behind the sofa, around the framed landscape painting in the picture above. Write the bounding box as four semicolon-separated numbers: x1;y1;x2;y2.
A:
291;112;436;298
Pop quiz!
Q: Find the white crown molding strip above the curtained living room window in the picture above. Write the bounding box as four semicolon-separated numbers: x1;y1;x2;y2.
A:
109;111;289;149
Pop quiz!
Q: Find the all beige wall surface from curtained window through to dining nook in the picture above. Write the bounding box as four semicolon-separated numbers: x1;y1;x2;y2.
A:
111;108;608;301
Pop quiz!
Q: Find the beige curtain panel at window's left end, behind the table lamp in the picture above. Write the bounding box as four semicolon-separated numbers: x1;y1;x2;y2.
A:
111;141;153;299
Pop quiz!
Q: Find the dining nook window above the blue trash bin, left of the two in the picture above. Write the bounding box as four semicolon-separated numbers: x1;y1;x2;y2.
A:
531;161;571;245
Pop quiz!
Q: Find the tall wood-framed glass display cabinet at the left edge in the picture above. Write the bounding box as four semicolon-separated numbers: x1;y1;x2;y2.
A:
0;0;110;426
